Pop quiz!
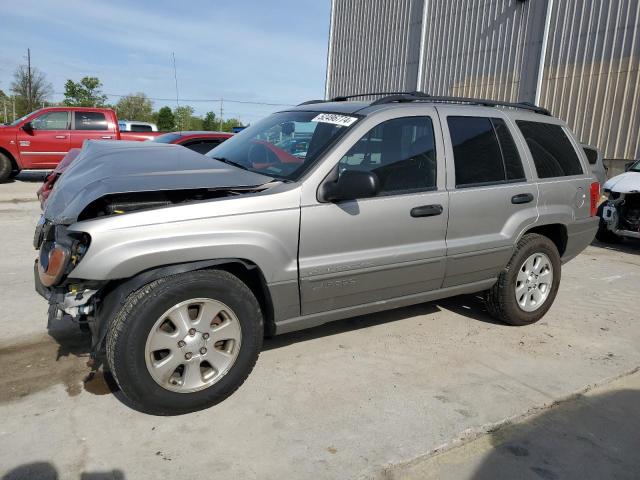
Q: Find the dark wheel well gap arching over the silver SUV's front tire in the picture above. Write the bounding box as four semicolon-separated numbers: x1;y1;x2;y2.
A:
92;259;275;353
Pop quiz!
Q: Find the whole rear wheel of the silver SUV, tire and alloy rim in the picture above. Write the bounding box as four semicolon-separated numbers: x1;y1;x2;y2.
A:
486;234;561;325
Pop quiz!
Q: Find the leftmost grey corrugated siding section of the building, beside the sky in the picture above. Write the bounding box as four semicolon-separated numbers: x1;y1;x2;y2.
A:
327;0;423;98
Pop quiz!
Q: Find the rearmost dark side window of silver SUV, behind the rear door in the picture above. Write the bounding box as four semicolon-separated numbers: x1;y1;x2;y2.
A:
516;120;583;178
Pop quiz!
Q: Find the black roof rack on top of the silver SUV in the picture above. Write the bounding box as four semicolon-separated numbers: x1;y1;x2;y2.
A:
300;91;551;116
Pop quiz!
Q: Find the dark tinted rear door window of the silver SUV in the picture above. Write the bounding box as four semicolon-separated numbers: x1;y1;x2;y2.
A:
447;116;525;187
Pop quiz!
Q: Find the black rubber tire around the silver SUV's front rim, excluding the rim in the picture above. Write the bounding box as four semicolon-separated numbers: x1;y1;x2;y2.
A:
106;270;263;415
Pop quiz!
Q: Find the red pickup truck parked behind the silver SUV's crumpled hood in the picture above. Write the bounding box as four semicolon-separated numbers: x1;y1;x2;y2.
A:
0;107;161;182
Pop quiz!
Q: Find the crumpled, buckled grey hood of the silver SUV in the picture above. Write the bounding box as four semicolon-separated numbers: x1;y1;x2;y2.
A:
44;140;272;224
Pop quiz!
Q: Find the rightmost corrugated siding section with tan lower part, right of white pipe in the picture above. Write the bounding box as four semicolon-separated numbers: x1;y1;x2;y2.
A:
540;0;640;159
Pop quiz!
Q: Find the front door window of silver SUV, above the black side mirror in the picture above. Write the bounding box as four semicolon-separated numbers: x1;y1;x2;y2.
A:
338;117;436;195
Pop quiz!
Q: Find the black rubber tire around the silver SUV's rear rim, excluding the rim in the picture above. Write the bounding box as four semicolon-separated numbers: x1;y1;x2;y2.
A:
486;233;561;326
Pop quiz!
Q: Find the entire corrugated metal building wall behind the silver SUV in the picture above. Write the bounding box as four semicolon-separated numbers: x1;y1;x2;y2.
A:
326;0;640;160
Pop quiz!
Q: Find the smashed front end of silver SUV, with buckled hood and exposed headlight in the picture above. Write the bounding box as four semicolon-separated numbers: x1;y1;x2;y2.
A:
33;141;273;356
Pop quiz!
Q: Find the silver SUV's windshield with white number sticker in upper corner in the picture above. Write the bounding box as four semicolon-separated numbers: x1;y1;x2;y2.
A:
207;112;360;181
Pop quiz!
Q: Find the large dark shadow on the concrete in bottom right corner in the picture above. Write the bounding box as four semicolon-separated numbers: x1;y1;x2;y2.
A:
464;389;640;480
